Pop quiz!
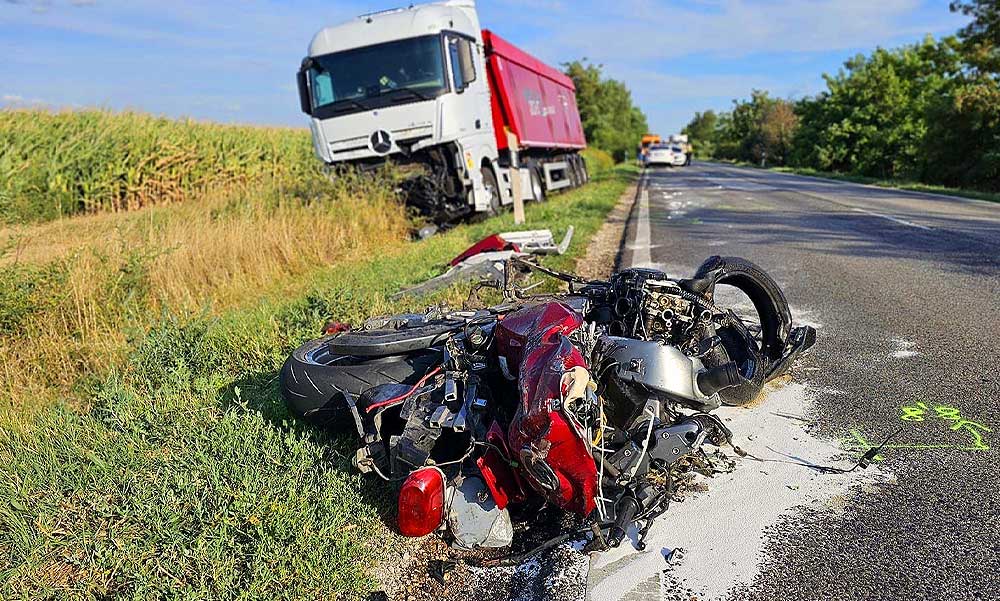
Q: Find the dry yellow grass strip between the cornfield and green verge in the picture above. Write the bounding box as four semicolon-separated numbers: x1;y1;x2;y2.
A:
0;169;409;409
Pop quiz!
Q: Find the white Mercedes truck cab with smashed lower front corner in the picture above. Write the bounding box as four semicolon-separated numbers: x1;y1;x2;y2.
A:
298;0;500;214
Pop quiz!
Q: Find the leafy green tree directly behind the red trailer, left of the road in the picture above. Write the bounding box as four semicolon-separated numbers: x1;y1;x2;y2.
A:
563;59;648;161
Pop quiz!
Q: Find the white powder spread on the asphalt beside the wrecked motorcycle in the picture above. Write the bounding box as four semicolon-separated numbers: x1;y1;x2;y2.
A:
590;382;887;600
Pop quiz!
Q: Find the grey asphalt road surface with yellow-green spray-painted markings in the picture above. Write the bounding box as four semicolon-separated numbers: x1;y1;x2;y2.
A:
624;163;1000;601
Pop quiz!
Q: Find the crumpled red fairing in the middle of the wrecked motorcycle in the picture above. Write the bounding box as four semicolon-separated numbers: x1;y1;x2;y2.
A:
497;302;597;515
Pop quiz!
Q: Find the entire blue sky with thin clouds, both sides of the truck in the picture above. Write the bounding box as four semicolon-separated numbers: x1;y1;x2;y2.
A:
0;0;964;133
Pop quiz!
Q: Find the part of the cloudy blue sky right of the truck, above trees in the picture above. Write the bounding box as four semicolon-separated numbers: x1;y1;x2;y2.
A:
480;0;964;131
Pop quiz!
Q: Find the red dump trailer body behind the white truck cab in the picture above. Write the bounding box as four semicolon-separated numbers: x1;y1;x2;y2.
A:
482;29;587;150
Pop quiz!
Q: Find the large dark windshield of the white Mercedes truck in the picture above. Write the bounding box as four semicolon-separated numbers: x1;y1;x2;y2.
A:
309;35;447;119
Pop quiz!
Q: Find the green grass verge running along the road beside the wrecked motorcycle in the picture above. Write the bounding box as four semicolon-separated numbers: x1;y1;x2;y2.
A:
0;167;634;599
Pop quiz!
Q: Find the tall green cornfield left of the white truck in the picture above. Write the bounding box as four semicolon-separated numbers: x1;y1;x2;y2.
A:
0;110;316;223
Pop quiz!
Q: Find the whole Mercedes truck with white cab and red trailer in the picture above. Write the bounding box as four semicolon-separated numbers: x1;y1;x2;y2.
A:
298;0;587;217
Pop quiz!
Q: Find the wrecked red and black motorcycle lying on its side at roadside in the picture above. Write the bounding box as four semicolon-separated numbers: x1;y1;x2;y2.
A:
281;257;816;549
